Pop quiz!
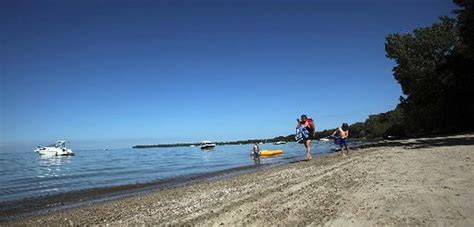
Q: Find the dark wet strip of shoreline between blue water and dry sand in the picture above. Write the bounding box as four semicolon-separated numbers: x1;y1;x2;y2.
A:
0;141;370;223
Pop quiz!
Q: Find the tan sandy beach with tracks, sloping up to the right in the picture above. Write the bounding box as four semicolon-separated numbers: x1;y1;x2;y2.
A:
1;135;474;226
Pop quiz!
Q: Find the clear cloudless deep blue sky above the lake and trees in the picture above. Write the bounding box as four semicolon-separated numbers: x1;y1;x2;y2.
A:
0;0;455;148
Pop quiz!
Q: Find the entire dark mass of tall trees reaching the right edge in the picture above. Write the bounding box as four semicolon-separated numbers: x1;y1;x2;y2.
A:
384;0;474;135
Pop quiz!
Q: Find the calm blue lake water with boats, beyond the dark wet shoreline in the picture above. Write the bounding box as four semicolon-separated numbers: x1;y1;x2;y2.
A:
0;142;360;201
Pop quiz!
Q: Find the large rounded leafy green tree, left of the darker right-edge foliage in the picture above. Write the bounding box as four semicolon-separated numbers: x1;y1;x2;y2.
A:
386;17;460;134
